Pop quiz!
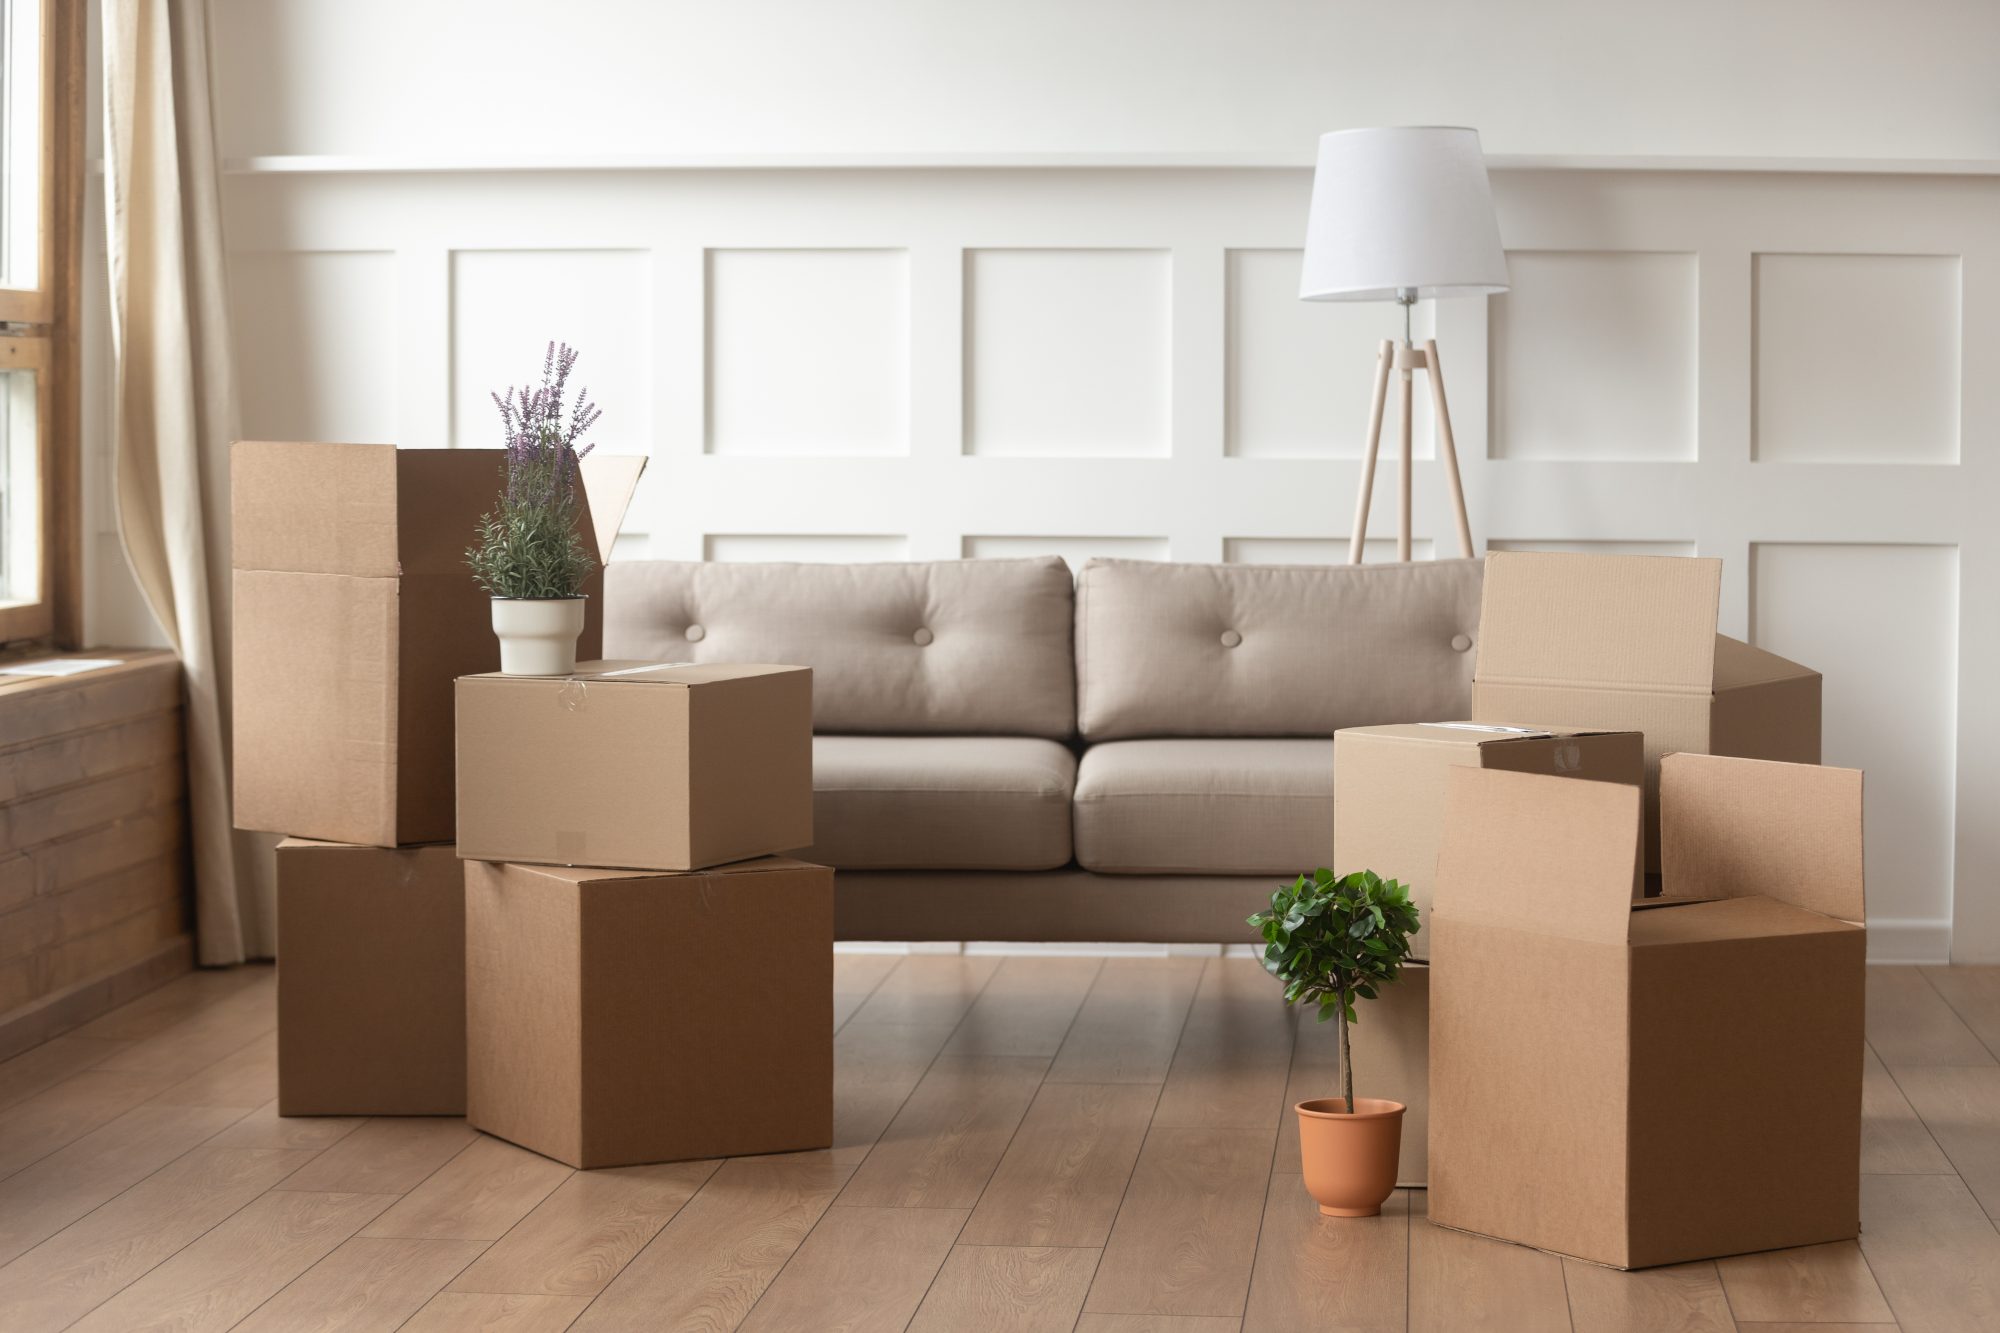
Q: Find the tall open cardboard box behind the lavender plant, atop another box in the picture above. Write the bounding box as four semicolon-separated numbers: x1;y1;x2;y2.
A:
230;440;646;847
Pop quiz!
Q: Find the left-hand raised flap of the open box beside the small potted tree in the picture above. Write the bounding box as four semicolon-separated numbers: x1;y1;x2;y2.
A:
1432;769;1640;945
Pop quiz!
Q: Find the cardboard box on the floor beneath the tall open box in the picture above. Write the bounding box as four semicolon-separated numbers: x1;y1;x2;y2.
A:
278;839;466;1115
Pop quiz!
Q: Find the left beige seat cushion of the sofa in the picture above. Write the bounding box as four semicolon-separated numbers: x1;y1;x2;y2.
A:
800;737;1076;871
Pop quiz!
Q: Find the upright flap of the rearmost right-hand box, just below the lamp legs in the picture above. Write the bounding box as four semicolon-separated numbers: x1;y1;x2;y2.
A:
1474;550;1722;693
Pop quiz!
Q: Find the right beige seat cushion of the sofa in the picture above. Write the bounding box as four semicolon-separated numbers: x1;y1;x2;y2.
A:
1076;739;1334;877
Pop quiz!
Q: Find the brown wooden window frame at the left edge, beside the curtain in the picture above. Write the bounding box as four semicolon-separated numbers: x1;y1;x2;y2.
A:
0;0;88;650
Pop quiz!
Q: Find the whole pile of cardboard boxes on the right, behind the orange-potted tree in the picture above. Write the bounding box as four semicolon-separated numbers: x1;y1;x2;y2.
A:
1334;554;1864;1267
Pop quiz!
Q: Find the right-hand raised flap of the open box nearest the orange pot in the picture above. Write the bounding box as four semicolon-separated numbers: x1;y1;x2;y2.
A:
1660;755;1868;923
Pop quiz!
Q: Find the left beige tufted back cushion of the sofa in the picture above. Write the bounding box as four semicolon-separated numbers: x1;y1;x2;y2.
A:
604;556;1076;741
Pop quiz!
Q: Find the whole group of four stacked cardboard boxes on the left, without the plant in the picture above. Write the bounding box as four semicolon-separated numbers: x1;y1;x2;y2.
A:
232;442;832;1167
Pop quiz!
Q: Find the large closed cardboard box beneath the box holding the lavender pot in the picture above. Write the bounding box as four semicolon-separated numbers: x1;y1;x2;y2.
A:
464;857;834;1167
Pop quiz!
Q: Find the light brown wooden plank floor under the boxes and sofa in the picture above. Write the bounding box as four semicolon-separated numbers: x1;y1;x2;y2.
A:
0;955;2000;1333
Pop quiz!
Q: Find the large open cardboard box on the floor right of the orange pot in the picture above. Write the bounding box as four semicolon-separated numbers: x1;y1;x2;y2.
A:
1430;755;1866;1269
